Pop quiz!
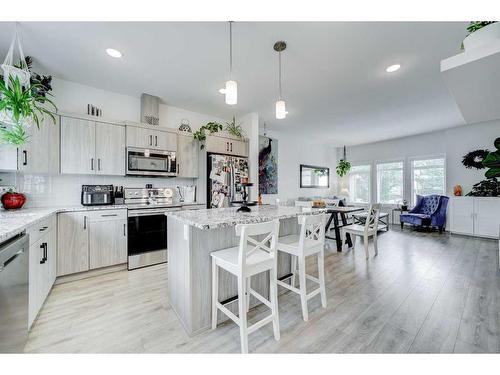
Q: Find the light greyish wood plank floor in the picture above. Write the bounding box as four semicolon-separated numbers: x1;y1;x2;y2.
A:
25;227;500;353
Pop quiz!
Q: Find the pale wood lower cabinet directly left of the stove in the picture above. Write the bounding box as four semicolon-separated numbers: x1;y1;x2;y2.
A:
57;209;127;276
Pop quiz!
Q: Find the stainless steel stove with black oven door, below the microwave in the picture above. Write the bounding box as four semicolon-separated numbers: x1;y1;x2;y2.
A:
125;188;181;270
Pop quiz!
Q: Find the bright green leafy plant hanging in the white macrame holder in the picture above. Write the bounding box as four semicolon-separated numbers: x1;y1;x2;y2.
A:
0;76;57;146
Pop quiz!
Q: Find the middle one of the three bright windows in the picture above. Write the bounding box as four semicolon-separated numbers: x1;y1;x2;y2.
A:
377;161;404;204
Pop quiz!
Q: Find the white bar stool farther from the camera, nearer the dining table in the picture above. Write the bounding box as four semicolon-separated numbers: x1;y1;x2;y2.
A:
278;213;326;321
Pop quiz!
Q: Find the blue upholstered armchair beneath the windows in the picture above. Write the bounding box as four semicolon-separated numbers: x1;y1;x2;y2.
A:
399;195;449;232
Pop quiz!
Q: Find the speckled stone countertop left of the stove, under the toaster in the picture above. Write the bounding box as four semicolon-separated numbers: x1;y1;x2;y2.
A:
0;205;127;242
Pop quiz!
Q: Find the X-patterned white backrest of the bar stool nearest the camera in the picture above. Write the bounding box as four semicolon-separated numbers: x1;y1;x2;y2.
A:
236;220;280;270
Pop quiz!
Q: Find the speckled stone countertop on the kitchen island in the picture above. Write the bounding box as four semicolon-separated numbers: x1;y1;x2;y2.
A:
166;206;324;230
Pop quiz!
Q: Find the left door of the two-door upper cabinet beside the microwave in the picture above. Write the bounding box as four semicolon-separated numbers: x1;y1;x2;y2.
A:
61;117;97;174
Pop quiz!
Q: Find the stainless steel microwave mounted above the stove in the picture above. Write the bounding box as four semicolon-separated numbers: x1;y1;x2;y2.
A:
127;147;177;177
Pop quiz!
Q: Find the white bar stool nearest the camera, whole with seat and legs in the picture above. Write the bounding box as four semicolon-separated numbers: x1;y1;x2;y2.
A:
210;220;280;353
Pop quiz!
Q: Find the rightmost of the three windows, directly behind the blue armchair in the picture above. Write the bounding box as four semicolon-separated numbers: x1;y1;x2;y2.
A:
411;157;446;204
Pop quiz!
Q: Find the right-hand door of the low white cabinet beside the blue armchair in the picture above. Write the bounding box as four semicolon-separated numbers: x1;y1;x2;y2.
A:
474;197;500;238
